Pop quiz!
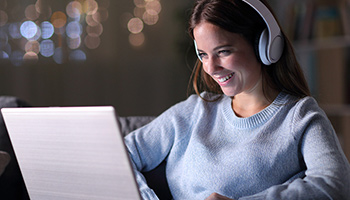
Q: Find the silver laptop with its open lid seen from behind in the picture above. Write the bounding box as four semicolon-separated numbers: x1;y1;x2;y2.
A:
1;106;141;200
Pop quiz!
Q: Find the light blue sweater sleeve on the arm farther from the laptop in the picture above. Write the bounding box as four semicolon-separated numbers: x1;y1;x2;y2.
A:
240;98;350;200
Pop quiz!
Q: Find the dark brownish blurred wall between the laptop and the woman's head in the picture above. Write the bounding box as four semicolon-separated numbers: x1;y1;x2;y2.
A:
0;0;194;116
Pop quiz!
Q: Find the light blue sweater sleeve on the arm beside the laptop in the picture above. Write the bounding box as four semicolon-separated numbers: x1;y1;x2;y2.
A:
125;97;195;199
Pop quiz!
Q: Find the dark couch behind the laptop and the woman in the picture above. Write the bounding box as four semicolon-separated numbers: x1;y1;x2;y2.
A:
0;96;172;200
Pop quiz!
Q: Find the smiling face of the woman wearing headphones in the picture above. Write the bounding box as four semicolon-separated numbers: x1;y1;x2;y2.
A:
193;22;262;97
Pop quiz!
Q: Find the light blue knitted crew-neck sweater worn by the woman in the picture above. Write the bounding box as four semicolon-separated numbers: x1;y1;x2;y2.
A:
125;93;350;200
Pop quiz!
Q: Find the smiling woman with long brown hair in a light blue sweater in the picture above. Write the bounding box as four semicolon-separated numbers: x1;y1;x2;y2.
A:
125;0;350;200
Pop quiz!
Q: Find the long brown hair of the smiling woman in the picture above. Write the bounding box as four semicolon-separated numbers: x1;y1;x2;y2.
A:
188;0;310;98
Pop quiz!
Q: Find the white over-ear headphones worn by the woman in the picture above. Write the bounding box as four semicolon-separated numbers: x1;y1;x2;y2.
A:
194;0;284;65
